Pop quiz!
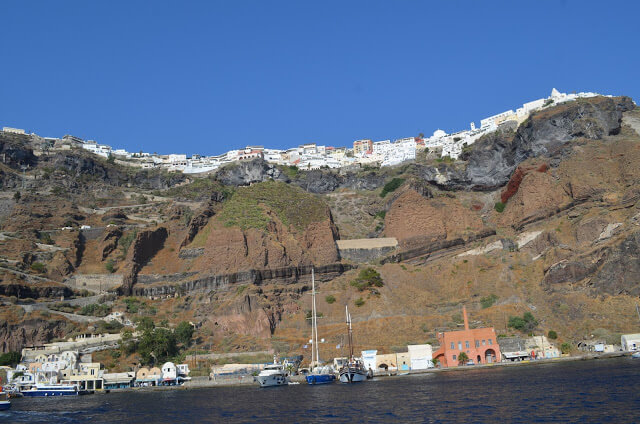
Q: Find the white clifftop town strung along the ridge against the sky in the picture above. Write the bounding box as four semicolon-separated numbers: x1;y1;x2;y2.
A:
3;88;598;174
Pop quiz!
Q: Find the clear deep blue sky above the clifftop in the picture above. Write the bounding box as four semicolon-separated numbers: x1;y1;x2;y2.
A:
0;0;640;154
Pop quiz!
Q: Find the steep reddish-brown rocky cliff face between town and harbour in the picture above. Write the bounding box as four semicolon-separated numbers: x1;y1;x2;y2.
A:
0;97;640;357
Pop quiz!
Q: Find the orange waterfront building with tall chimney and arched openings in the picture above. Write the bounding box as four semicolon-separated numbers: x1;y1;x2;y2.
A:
433;307;502;367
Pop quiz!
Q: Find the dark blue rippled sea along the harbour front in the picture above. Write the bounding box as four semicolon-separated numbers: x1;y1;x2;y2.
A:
5;358;640;424
